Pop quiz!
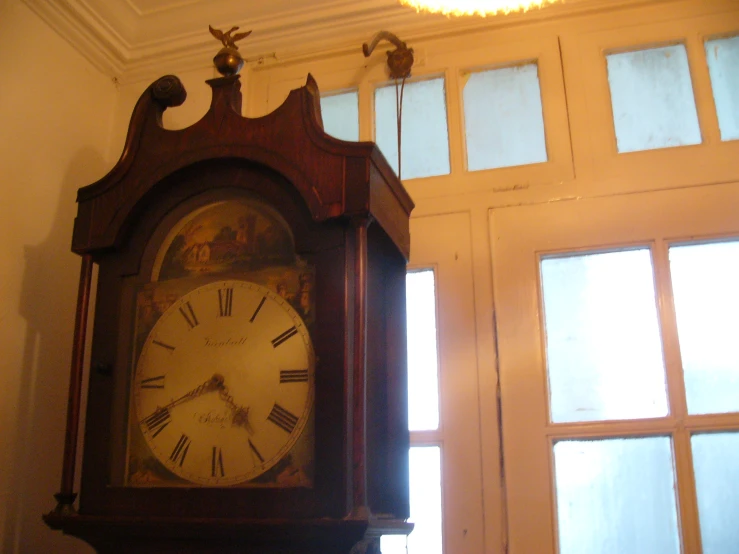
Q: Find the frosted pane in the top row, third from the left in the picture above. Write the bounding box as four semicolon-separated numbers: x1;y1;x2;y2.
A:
464;63;547;171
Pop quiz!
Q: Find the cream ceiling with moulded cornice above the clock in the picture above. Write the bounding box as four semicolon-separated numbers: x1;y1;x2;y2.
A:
23;0;656;82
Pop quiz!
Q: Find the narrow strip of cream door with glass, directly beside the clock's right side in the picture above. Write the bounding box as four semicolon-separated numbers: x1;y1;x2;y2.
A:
398;213;484;554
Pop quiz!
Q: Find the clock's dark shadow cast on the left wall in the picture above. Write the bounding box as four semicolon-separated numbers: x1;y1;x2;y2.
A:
1;148;107;554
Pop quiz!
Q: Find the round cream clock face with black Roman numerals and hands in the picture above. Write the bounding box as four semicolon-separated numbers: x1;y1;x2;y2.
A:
132;280;314;486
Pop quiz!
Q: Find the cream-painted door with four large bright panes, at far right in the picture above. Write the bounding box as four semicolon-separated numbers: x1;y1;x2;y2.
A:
490;184;739;554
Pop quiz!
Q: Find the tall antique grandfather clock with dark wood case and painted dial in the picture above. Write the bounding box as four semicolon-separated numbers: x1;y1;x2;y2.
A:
44;37;413;554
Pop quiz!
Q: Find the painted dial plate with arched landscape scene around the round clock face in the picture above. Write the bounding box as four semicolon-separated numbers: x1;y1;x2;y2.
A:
126;199;315;487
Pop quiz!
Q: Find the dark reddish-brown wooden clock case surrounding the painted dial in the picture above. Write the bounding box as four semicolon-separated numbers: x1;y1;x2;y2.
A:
44;76;413;553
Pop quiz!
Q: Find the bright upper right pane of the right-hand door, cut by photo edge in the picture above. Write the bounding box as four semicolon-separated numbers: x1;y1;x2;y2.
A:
670;242;739;414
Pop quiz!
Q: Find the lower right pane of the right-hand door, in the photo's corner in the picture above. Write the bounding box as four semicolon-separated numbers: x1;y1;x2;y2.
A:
691;433;739;554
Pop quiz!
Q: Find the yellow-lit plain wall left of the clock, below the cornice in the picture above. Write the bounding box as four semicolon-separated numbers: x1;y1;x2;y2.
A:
0;0;116;554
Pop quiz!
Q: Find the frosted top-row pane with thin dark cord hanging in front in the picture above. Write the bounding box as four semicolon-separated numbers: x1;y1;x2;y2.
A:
375;79;449;179
